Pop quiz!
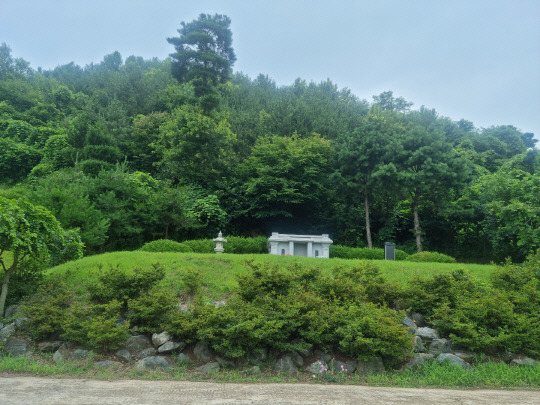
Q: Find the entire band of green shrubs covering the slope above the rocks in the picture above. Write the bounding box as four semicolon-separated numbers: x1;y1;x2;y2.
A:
11;248;540;365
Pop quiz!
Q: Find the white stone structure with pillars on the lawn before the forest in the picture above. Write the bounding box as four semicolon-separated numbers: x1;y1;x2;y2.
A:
268;232;332;258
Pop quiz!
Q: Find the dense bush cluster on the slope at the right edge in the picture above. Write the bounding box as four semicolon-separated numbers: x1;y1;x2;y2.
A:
405;263;540;356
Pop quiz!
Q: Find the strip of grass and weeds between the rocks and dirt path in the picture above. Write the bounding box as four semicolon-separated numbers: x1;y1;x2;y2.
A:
0;355;540;389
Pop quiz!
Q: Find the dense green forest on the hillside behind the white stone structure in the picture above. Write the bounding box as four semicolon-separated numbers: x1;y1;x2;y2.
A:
0;15;540;262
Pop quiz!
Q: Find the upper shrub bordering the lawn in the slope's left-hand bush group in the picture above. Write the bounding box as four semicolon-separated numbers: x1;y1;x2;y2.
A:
88;263;165;308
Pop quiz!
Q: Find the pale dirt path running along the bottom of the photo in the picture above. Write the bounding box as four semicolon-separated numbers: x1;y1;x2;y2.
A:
0;376;540;405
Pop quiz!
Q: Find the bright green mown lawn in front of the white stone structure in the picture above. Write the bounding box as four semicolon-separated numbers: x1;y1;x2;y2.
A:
47;251;495;299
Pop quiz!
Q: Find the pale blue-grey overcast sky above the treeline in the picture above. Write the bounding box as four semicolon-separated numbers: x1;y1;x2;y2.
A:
0;0;540;139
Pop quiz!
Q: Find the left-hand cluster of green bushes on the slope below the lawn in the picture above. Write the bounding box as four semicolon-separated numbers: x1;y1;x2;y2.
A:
21;264;162;350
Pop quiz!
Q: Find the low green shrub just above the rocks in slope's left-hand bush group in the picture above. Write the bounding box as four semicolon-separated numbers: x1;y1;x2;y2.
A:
62;300;131;351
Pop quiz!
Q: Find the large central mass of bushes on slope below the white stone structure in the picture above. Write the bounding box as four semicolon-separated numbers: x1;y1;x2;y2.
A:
168;263;411;362
